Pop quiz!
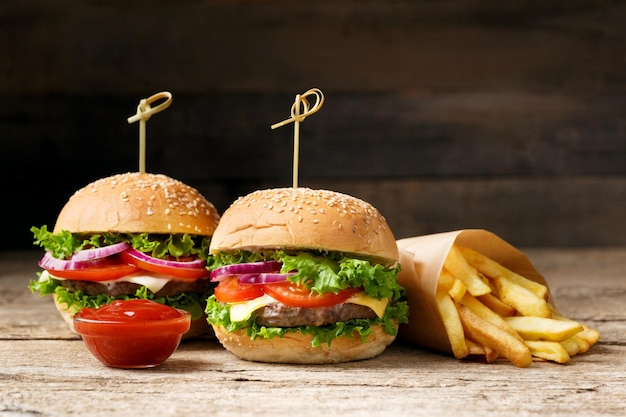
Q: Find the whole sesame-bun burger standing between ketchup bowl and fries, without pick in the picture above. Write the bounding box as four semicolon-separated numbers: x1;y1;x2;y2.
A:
206;188;408;364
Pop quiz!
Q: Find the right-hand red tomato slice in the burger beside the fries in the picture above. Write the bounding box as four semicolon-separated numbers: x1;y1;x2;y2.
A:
263;281;361;308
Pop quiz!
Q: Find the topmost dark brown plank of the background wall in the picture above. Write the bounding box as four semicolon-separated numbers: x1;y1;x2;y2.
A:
0;0;626;95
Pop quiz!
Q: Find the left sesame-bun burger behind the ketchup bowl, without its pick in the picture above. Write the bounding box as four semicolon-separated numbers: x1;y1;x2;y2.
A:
30;173;220;338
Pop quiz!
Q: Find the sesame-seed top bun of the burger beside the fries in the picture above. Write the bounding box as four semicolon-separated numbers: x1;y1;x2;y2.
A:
210;188;398;264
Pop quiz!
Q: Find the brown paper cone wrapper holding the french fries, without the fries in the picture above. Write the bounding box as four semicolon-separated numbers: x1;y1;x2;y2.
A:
397;229;547;354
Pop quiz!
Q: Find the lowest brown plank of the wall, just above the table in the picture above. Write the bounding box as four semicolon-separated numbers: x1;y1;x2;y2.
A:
11;177;626;249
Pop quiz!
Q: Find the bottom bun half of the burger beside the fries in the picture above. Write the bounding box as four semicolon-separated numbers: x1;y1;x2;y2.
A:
213;325;396;364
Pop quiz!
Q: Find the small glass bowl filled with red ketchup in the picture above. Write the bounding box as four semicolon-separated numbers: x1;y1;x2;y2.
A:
74;299;191;368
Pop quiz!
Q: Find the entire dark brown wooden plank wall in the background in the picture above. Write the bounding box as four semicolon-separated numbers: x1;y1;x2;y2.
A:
0;0;626;249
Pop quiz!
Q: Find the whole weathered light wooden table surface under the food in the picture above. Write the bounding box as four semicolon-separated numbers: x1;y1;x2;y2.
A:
0;248;626;416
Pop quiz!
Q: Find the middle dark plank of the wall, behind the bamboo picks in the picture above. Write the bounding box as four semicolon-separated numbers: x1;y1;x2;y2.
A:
0;92;626;180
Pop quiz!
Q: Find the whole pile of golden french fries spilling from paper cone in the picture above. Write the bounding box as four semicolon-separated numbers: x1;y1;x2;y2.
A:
437;244;600;368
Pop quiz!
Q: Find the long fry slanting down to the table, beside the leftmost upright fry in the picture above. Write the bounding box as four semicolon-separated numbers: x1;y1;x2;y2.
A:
459;304;533;368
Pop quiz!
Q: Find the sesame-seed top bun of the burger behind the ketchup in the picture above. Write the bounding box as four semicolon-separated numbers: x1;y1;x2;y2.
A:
54;172;219;236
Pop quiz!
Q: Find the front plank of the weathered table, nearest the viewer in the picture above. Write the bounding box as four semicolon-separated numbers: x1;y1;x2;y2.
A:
0;341;626;417
